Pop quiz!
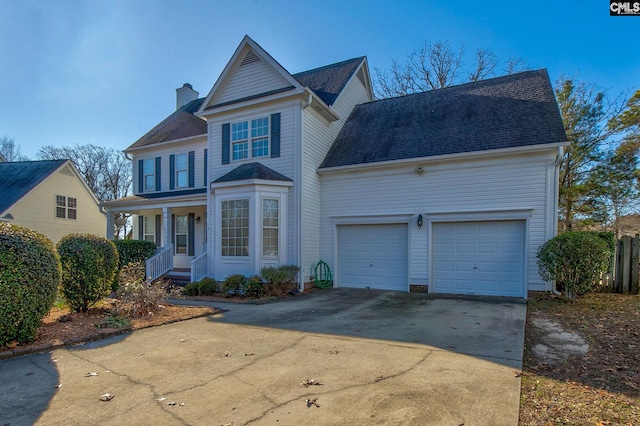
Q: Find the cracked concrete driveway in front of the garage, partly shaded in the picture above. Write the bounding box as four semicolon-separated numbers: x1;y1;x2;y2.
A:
0;289;526;426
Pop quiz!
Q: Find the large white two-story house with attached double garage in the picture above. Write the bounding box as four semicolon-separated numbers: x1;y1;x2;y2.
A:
106;37;567;297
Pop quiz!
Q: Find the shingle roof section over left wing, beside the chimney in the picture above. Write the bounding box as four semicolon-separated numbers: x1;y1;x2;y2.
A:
127;98;207;149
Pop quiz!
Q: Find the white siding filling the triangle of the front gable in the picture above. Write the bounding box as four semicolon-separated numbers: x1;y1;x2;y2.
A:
214;52;291;105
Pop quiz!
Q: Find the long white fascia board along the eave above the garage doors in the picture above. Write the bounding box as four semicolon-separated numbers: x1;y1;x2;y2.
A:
317;141;570;175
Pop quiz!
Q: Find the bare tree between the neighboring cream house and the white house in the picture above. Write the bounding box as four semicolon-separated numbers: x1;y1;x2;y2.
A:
38;144;132;236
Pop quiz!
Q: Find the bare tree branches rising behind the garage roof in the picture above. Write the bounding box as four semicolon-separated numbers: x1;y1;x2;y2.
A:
374;41;526;98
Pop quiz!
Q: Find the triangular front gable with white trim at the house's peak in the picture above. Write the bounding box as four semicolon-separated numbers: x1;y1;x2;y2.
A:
199;36;303;115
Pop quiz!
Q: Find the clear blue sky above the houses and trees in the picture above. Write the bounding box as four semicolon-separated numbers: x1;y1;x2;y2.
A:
0;0;640;158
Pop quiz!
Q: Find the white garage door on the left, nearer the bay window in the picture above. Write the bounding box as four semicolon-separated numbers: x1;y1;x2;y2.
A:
338;224;408;291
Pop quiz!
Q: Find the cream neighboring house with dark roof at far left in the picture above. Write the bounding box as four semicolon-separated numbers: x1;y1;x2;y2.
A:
0;160;107;244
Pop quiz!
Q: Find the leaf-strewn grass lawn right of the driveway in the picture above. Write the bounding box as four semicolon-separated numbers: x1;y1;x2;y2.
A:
520;293;640;425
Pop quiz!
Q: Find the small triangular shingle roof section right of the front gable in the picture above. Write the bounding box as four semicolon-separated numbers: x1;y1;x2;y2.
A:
293;56;365;106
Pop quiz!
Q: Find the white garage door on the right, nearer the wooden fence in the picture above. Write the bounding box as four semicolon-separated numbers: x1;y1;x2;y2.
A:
432;221;525;297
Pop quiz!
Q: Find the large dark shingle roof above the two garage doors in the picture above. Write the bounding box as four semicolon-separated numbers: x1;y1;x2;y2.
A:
320;69;567;168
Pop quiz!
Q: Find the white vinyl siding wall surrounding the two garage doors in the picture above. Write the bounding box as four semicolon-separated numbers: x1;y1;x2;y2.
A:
319;151;555;290
